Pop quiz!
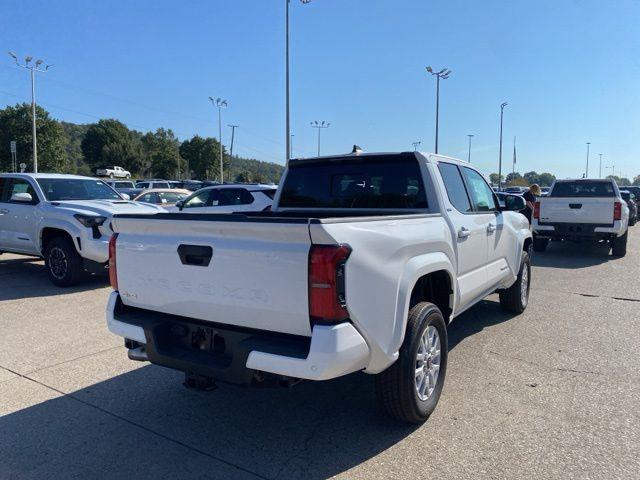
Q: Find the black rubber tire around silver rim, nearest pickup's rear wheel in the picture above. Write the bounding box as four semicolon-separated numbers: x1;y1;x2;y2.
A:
375;302;448;423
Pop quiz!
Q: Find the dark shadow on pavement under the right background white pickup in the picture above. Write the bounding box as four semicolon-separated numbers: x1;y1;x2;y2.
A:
531;242;615;268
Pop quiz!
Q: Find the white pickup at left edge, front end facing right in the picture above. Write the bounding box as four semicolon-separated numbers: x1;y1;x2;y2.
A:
0;173;164;286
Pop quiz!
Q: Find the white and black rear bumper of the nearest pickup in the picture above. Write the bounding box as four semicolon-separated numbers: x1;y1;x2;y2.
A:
107;292;369;385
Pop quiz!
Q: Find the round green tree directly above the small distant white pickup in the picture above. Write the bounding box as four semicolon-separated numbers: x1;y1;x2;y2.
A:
81;119;144;173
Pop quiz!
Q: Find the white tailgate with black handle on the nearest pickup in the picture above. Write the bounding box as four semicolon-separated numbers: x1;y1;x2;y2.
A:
113;214;311;336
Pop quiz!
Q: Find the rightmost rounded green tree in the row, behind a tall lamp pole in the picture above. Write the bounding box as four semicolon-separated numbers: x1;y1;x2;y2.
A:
180;135;228;180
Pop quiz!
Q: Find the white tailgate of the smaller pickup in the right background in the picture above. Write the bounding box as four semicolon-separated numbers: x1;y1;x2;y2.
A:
540;197;615;225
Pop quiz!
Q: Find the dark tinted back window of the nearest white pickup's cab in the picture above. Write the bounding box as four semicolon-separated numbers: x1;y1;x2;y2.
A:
280;155;428;210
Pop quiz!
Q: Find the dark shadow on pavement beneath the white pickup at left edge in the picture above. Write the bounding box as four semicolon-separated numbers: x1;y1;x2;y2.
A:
0;257;109;301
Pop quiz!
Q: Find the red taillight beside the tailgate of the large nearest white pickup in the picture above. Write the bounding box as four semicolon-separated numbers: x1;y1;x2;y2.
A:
309;245;351;323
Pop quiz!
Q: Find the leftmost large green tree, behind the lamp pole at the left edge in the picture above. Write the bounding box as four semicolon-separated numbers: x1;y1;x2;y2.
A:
0;103;68;172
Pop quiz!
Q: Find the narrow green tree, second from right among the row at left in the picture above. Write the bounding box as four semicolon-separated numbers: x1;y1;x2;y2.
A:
141;128;184;178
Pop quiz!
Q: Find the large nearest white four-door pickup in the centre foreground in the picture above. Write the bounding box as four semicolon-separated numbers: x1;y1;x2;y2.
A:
107;152;532;422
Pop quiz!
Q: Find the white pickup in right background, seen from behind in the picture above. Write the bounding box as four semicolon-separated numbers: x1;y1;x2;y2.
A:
532;179;629;257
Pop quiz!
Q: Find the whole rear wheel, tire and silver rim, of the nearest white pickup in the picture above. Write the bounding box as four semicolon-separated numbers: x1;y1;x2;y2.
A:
376;302;447;423
